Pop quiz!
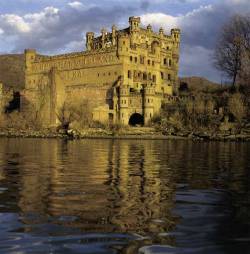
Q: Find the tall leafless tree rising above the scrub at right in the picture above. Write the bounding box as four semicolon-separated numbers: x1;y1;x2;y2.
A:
214;15;250;86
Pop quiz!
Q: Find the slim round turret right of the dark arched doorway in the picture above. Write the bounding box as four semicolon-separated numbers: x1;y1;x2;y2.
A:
143;81;155;125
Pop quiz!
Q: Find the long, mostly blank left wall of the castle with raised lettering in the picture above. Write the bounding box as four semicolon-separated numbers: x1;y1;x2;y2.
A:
23;50;122;124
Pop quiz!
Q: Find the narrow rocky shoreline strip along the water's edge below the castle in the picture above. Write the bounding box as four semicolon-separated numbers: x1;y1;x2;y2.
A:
0;127;250;142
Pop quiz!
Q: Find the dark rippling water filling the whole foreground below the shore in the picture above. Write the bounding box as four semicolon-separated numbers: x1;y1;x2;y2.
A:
0;139;250;254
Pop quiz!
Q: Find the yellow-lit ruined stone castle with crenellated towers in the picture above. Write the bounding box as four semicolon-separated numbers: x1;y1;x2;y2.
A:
21;17;180;126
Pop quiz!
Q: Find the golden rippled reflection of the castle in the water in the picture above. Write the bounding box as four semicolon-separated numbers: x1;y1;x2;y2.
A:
1;140;178;235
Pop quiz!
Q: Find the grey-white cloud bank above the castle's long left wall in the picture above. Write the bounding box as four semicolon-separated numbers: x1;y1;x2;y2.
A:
0;2;136;54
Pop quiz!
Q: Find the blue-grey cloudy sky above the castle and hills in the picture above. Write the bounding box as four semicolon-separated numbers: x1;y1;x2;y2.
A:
0;0;250;82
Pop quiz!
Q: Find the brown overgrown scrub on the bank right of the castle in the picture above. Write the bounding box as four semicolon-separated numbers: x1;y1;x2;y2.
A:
153;90;250;136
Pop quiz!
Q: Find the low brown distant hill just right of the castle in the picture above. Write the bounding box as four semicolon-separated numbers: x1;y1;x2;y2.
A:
179;77;221;92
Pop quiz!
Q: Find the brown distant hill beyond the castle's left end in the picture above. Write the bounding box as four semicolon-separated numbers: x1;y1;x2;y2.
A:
0;54;24;90
